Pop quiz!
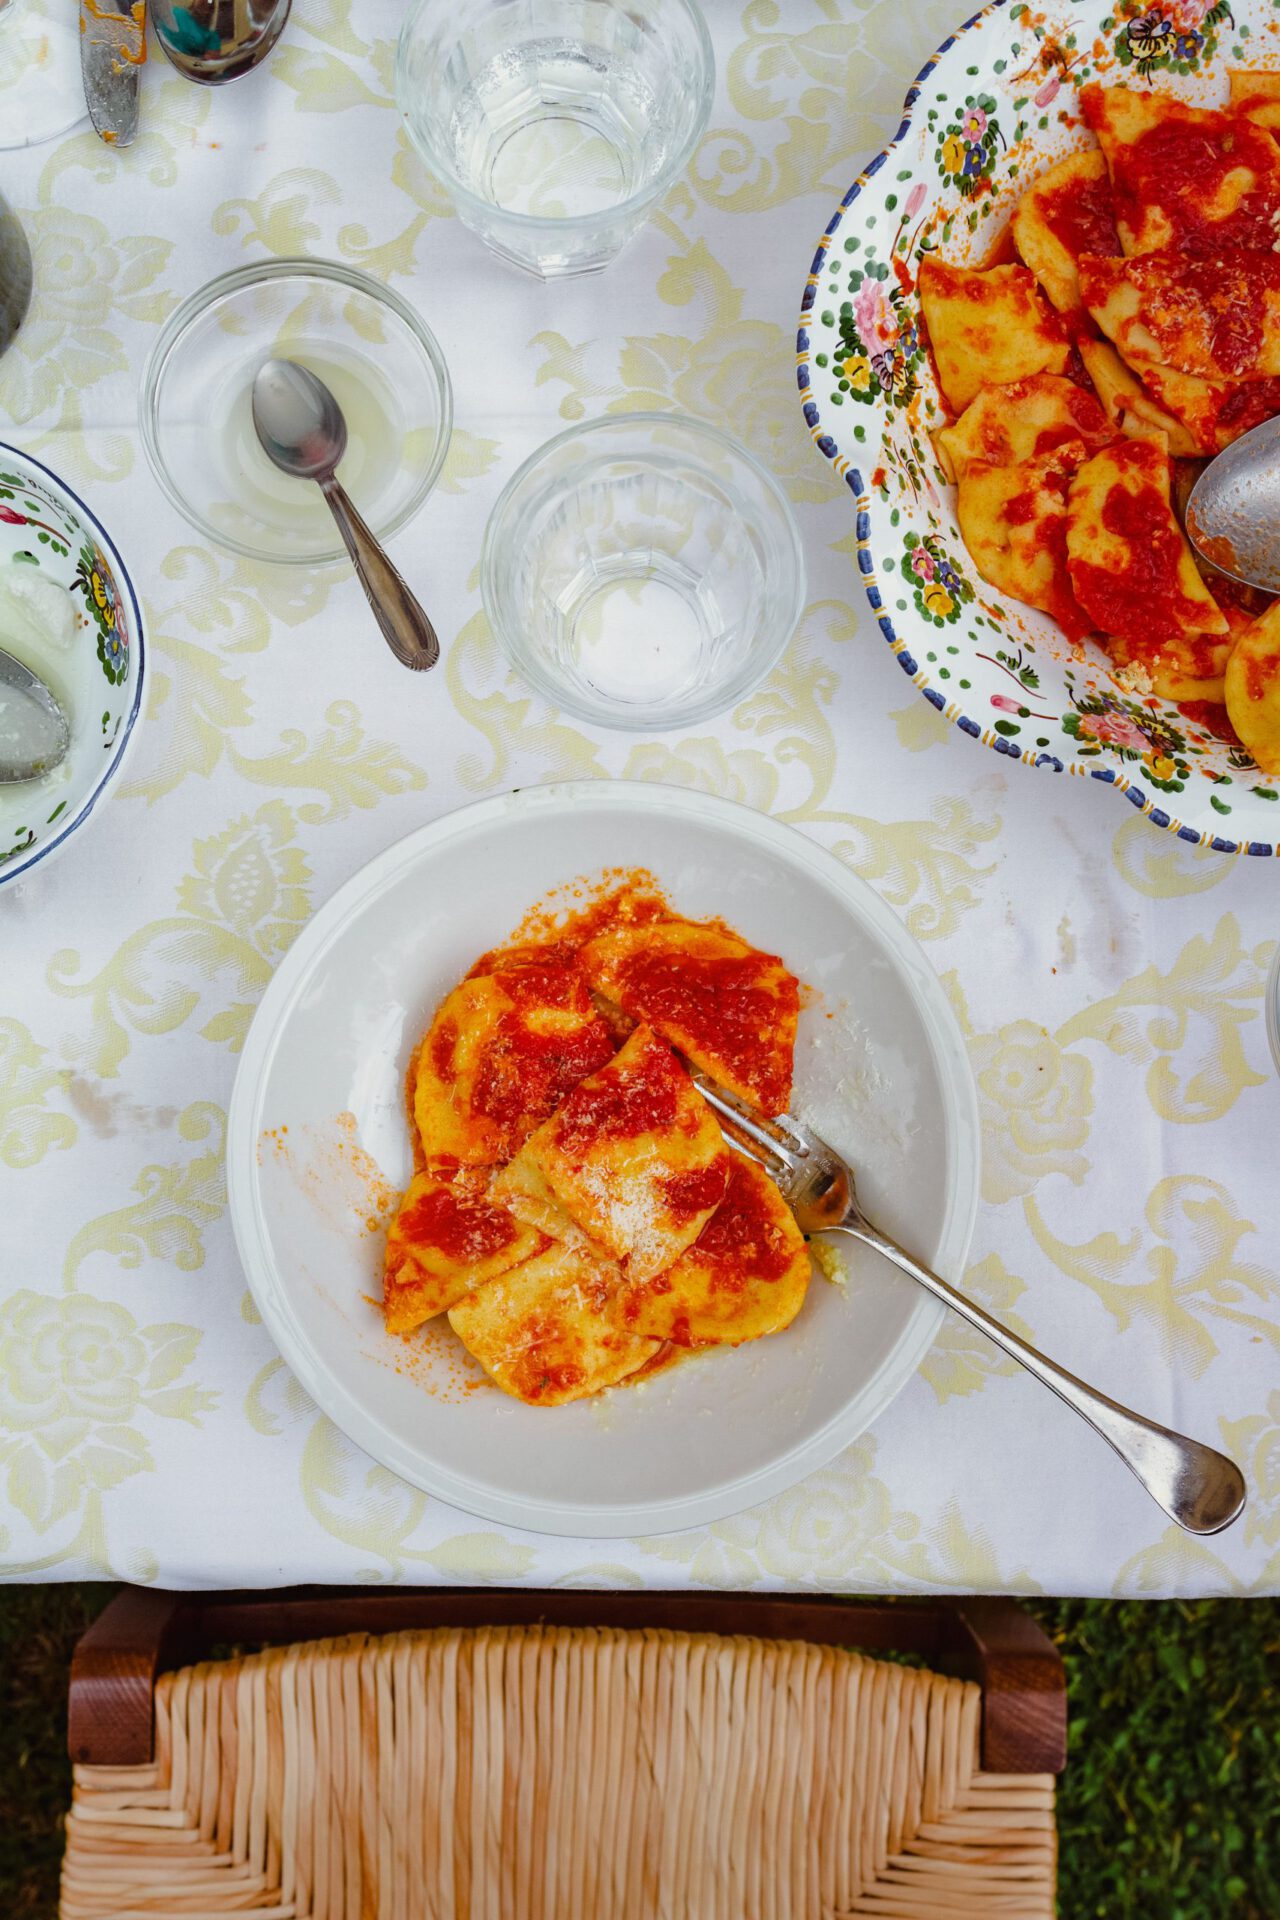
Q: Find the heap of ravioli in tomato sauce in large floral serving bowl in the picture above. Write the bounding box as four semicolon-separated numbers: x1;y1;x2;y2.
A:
919;71;1280;774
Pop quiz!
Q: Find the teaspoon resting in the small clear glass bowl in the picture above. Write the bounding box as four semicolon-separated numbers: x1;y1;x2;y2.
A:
253;359;439;672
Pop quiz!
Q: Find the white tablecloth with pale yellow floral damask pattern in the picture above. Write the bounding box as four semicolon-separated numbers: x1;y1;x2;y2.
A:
0;0;1280;1594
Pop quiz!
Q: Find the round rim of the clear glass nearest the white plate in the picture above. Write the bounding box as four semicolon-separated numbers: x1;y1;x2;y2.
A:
480;409;806;733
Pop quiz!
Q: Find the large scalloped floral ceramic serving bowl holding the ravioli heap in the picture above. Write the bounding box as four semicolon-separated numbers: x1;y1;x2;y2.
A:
796;0;1280;854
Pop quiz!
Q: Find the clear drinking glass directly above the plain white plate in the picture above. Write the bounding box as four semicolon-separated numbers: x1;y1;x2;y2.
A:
480;413;804;732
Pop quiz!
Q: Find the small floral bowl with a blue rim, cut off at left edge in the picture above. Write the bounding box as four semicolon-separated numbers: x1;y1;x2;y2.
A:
0;442;144;887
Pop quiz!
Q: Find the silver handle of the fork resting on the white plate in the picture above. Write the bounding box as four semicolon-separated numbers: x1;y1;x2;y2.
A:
829;1213;1245;1534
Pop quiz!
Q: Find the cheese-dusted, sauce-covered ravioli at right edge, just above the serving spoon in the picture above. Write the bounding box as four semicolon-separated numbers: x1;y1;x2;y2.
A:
1080;248;1280;382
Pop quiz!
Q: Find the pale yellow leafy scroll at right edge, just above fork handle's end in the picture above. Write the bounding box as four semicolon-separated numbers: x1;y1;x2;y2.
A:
1023;1173;1280;1377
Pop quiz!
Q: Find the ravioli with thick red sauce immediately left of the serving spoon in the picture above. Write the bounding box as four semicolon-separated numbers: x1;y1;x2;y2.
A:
1067;440;1226;645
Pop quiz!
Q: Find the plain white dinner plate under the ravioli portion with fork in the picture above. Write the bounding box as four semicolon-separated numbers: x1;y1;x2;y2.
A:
228;781;979;1538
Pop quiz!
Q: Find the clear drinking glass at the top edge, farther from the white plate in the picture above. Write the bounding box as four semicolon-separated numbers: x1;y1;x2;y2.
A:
395;0;714;278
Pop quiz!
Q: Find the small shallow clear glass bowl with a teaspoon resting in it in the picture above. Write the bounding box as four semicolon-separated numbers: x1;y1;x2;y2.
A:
140;259;453;566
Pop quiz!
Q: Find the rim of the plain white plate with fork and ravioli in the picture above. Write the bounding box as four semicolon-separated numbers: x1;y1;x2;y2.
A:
226;780;981;1540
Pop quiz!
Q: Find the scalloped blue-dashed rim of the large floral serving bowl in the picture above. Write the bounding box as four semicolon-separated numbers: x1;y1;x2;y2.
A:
796;0;1280;858
